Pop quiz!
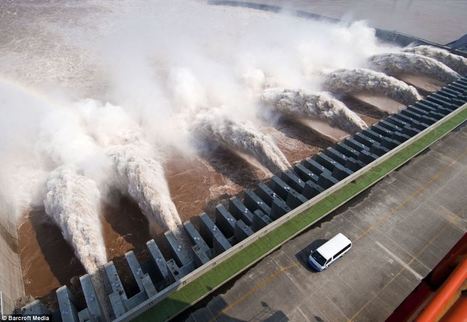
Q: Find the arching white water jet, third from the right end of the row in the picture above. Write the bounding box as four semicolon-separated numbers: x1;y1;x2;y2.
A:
323;68;422;104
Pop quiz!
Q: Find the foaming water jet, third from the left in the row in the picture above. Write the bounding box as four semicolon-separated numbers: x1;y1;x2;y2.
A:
193;110;290;173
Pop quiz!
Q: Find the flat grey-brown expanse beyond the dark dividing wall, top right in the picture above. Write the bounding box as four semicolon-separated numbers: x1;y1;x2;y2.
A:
218;0;467;44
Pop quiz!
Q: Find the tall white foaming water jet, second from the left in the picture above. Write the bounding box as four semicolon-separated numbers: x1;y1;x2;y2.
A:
80;100;182;233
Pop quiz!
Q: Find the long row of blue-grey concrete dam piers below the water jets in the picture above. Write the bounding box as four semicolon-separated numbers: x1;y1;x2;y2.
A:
18;77;467;321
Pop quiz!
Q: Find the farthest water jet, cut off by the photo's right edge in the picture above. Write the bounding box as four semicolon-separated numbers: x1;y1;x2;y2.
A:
404;45;467;75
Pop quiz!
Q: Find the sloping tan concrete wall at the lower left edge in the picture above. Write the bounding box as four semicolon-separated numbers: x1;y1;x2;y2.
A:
0;196;24;313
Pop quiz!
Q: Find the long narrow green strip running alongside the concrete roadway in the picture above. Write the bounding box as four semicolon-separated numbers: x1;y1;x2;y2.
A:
135;108;467;322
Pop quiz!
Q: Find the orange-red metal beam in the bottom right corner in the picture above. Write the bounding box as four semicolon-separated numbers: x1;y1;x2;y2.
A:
416;259;467;322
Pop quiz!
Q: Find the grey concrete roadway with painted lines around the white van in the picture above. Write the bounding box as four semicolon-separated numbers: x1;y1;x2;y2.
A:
187;126;467;321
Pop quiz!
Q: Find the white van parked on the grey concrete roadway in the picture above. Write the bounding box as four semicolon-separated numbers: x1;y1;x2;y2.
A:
308;233;352;272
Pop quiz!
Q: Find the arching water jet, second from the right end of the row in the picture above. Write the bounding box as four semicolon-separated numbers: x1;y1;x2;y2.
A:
369;53;460;82
